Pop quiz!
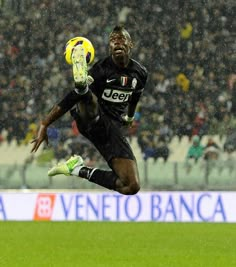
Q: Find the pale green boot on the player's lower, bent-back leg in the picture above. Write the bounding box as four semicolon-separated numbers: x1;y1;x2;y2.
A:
48;155;84;176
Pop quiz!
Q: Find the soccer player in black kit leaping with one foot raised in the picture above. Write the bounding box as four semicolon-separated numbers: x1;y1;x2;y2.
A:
31;26;147;195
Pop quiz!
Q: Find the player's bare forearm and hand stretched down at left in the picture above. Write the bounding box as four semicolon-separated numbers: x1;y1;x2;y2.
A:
31;105;67;153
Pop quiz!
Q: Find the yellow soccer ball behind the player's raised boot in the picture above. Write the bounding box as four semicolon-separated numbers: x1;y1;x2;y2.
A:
64;36;95;65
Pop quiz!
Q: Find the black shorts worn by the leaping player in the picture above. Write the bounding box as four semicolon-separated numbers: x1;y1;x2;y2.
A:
72;109;136;167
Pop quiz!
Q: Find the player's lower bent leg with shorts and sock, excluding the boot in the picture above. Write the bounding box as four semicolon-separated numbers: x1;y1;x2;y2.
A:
77;117;140;194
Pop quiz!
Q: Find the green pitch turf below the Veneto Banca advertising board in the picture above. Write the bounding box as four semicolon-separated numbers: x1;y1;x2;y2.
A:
0;222;236;267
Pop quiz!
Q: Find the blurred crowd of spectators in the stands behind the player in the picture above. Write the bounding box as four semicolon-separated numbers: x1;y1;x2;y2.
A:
0;0;236;164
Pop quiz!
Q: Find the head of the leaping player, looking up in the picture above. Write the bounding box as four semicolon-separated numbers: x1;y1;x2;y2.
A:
109;26;133;66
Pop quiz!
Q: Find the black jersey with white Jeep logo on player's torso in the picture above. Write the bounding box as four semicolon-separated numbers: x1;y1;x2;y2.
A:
89;56;147;120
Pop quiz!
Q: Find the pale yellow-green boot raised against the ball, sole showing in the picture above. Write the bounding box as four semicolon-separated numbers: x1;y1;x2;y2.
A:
71;45;88;89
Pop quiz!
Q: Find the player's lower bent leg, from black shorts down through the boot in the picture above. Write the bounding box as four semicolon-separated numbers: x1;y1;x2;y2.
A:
48;113;140;195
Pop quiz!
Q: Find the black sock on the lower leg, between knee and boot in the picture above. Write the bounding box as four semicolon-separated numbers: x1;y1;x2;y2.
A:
79;167;118;190
